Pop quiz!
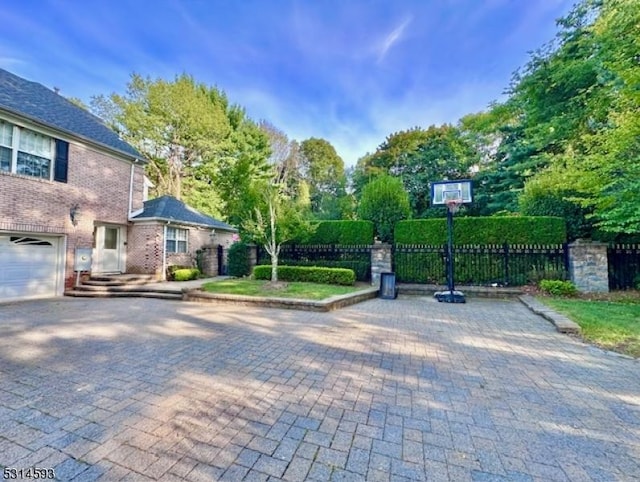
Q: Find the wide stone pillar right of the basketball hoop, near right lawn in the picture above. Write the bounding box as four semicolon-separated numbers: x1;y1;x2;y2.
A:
569;239;609;293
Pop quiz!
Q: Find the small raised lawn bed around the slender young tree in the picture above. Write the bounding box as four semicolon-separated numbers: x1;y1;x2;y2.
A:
202;279;362;300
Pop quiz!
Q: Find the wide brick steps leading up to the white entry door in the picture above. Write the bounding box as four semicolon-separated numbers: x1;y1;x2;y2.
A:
64;274;182;300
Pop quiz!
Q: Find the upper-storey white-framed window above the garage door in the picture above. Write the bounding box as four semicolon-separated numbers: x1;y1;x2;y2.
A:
0;120;58;181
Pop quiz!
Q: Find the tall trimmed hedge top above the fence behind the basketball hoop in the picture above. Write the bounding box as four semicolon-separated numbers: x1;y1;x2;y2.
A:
395;216;567;245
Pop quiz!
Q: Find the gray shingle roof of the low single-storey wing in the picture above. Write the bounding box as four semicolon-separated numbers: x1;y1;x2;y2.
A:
133;196;237;231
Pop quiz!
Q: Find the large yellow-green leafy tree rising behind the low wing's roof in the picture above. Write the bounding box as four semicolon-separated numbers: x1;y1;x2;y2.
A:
91;74;270;220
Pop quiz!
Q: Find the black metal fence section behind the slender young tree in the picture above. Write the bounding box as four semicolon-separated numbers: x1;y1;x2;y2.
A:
258;244;371;281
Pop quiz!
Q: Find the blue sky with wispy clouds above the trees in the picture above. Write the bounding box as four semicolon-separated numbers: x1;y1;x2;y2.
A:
0;0;573;165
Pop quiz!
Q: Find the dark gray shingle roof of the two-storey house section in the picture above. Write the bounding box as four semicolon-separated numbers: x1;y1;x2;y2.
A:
0;69;143;160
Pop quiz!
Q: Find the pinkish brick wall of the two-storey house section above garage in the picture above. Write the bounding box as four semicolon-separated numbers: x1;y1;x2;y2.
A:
0;137;144;287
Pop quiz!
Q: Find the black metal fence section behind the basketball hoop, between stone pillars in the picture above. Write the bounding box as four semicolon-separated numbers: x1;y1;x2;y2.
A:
393;244;568;286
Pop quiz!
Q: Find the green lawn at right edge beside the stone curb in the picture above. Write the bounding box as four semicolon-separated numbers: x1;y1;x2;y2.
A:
538;297;640;357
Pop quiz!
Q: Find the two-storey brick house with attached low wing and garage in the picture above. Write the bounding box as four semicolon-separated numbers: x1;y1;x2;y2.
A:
0;69;235;301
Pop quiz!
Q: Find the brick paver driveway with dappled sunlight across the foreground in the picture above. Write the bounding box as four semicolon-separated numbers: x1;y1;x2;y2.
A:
0;297;640;482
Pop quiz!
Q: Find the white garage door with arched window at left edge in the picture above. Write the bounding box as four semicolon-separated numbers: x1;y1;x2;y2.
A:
0;233;64;301
